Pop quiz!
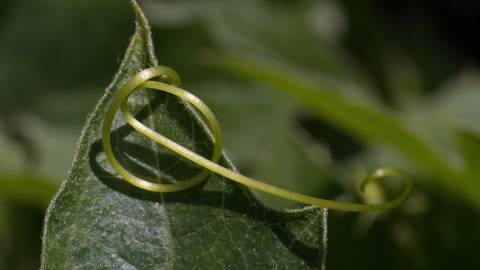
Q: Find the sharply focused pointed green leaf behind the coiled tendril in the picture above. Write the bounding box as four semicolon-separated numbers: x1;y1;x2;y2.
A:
42;1;326;269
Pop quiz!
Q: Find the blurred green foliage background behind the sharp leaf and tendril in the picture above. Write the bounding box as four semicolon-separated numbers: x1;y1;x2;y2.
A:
0;0;480;269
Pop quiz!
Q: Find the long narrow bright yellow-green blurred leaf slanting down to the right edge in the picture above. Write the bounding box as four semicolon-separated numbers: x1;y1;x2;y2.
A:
217;53;480;207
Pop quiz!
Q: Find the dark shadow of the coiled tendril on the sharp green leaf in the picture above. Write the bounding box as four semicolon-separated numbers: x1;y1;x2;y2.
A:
89;92;325;268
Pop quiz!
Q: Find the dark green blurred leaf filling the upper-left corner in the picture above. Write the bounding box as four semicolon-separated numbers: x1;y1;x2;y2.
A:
0;0;132;128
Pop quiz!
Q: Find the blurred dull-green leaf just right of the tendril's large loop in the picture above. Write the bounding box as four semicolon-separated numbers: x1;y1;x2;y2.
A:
194;80;332;208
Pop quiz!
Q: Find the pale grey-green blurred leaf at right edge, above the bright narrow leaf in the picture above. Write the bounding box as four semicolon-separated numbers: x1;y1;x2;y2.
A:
403;70;480;161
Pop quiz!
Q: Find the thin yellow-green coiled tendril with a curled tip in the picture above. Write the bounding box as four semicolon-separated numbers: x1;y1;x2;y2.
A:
102;66;412;212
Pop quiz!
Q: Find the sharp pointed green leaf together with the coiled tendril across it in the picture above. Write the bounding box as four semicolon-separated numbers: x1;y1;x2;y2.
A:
37;1;411;269
